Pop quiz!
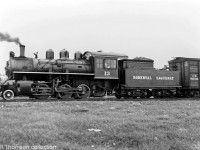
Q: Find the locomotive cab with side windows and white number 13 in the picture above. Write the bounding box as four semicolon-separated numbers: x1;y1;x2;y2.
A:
82;51;128;96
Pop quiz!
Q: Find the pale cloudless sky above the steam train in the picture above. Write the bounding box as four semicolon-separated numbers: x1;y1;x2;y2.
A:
0;0;200;74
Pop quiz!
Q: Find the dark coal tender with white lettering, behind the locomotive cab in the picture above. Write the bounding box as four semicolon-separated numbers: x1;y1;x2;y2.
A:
115;59;180;98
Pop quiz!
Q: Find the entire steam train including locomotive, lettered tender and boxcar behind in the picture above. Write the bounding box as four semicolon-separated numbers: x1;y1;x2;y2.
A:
0;45;200;100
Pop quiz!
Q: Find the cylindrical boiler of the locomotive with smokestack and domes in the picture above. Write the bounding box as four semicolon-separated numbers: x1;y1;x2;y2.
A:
6;45;93;79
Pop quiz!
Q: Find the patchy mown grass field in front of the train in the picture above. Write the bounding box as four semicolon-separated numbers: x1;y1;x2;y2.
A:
0;99;200;150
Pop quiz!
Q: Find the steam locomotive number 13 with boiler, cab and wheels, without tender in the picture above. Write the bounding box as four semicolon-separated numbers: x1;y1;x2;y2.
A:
1;45;127;100
